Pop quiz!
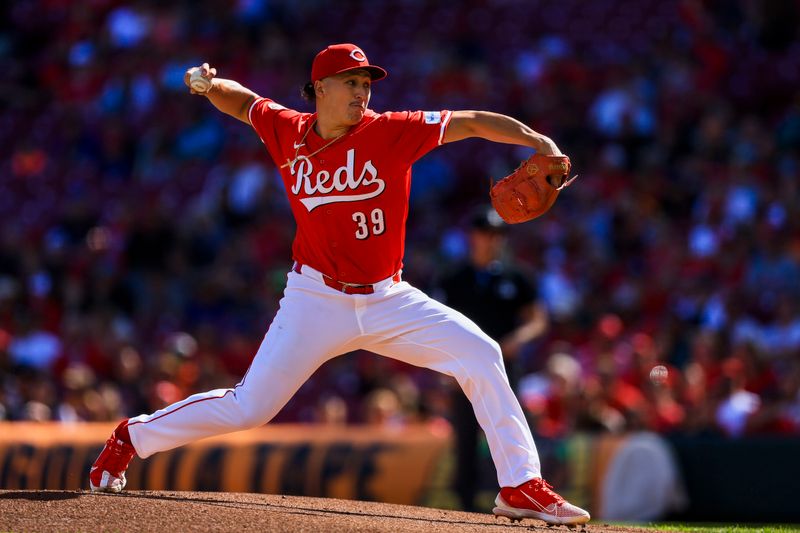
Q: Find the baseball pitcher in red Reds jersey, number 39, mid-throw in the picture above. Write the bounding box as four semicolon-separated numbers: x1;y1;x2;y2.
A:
89;44;589;524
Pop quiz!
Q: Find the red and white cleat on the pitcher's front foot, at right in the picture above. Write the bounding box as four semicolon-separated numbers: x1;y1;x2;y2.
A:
493;478;589;525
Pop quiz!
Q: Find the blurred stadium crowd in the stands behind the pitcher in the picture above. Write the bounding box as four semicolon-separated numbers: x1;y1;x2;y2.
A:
0;0;800;437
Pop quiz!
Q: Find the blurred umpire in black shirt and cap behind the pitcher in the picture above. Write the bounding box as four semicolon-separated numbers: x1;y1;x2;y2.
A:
434;207;549;511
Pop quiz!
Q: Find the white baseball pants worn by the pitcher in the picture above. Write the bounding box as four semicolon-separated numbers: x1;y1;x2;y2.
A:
129;265;540;487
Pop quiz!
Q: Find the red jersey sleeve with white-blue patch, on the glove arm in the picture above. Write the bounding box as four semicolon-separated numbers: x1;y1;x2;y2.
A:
390;111;452;163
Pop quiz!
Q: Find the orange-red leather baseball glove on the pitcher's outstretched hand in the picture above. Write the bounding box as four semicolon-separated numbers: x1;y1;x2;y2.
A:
490;153;578;224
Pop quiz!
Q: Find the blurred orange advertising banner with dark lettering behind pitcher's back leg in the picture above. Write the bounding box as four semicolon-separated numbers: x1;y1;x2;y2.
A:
0;422;451;504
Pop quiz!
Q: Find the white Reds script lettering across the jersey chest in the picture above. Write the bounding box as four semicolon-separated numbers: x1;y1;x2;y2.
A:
289;148;386;212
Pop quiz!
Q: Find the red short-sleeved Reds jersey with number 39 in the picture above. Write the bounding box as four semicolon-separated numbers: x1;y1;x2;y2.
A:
248;98;451;284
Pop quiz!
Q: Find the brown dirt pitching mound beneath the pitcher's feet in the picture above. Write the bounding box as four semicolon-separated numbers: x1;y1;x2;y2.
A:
0;491;668;533
